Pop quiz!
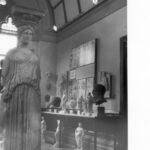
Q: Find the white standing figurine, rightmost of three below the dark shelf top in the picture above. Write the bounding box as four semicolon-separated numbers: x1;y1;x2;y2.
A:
75;123;84;150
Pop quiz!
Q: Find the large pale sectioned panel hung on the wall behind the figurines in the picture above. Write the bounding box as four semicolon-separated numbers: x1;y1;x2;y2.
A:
68;39;98;99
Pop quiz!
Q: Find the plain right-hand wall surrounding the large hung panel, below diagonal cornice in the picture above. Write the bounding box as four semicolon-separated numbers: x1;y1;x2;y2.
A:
55;7;127;112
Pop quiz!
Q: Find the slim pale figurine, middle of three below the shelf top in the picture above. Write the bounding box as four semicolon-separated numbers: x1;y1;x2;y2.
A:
54;120;63;148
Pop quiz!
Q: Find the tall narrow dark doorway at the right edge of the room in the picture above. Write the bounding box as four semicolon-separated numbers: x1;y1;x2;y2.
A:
120;36;128;150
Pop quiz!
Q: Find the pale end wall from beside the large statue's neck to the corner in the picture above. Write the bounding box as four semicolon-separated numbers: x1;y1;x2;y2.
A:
30;41;56;108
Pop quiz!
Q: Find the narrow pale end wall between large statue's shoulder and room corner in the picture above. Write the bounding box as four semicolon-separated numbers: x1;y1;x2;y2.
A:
38;41;56;106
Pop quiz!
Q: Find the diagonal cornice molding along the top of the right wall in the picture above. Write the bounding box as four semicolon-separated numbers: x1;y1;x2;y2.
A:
56;0;127;42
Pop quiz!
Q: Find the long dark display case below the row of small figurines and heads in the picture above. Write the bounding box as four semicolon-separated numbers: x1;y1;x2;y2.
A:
42;111;121;150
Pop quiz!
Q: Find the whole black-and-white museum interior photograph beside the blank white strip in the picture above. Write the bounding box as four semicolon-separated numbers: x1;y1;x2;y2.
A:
0;0;129;150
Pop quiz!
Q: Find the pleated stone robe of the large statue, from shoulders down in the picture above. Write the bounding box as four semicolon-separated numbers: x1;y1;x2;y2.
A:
2;48;41;150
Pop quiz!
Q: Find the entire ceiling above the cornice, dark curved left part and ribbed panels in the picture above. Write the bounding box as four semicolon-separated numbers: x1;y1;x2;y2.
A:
0;0;108;30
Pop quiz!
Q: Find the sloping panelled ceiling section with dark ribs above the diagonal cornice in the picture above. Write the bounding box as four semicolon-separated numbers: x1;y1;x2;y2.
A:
46;0;106;29
